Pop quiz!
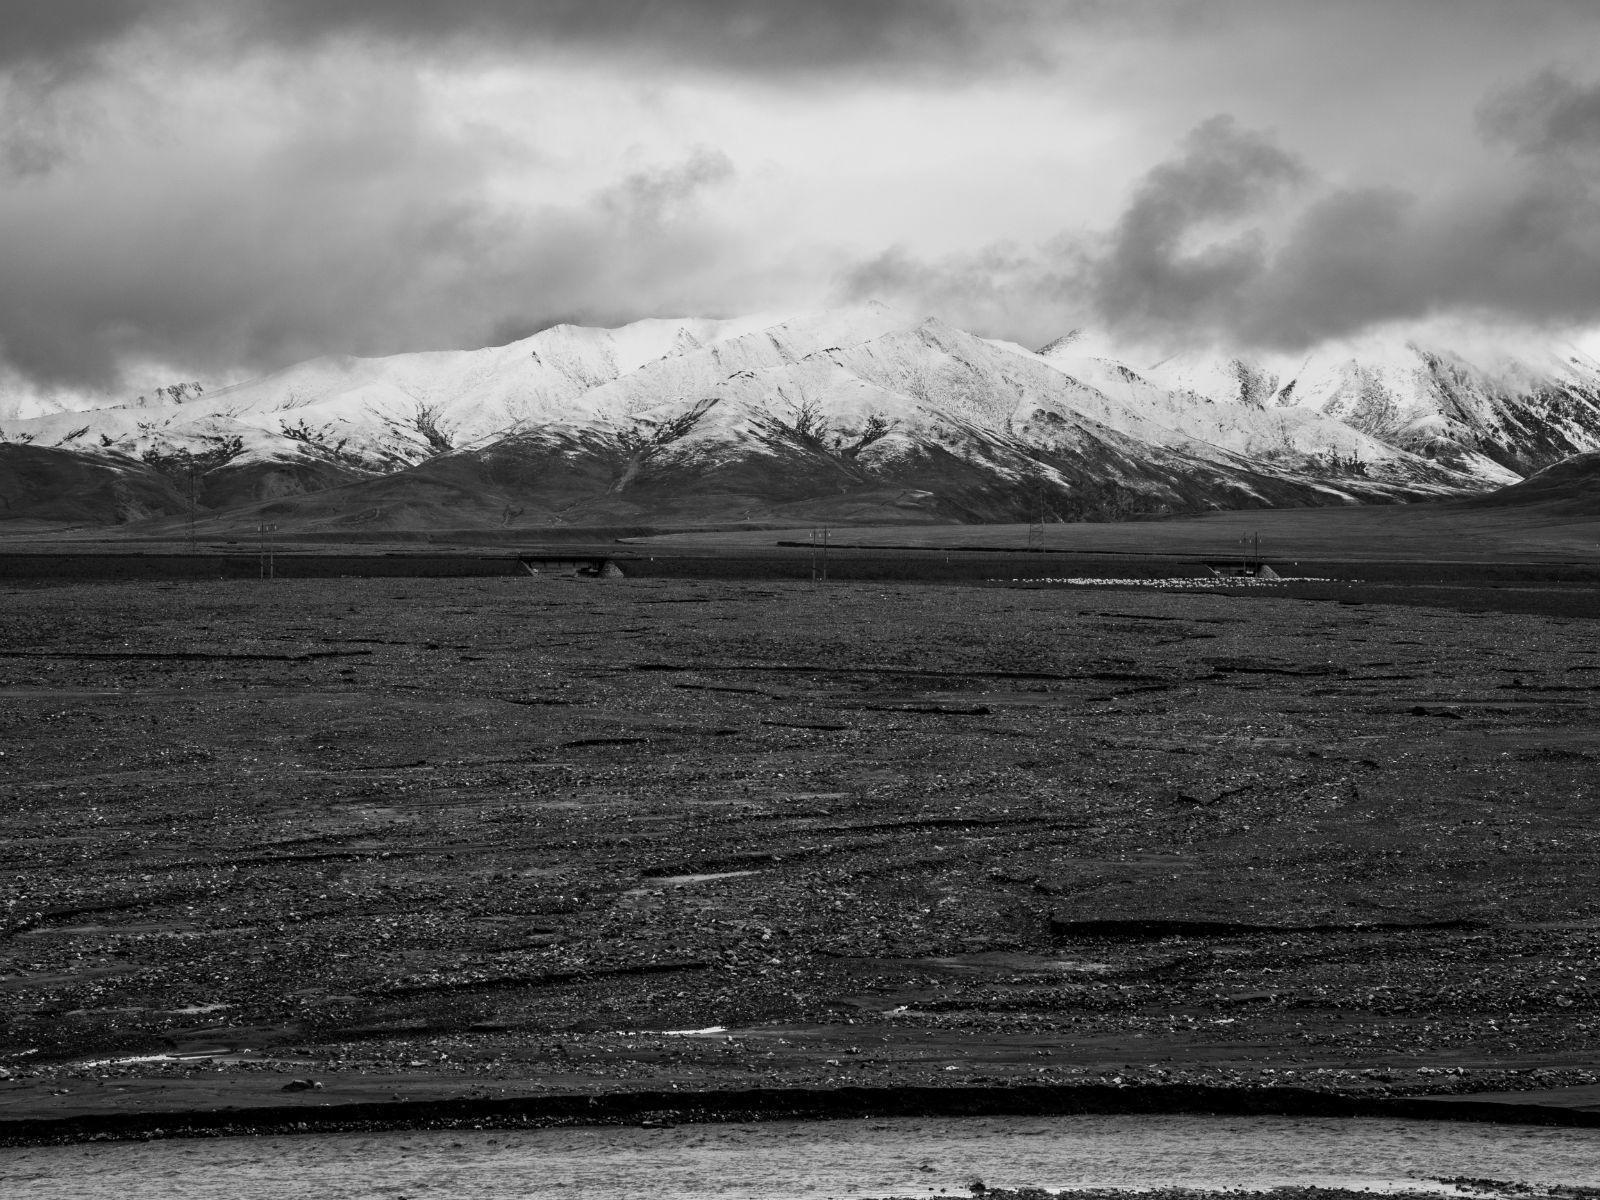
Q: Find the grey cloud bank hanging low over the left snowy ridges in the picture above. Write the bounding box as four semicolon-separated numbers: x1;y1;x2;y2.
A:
0;55;741;389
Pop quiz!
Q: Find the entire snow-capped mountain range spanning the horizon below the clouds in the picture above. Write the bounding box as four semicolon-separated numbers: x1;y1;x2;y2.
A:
0;304;1600;520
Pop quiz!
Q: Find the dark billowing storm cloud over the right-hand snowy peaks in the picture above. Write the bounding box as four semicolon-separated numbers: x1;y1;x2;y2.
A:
842;72;1600;350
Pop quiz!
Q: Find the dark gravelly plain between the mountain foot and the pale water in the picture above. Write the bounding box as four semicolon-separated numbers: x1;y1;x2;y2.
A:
0;576;1600;1138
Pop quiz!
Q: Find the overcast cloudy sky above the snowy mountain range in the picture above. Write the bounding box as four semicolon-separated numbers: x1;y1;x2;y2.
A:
0;0;1600;404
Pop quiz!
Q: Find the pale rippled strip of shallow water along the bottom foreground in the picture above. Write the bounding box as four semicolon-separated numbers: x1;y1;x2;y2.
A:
0;1117;1600;1200
